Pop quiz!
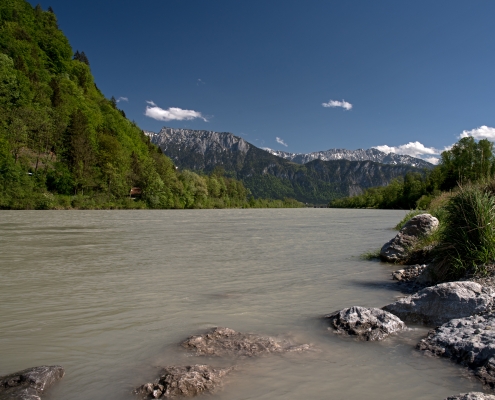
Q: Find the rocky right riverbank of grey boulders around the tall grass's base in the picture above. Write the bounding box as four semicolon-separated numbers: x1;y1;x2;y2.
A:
380;214;495;400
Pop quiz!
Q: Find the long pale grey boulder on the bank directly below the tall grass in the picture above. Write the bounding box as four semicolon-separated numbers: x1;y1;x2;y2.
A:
383;281;495;325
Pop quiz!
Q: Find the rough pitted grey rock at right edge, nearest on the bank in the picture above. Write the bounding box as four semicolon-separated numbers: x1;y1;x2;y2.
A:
417;314;495;387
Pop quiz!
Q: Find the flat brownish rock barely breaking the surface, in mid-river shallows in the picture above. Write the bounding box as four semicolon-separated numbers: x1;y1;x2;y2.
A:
181;328;310;357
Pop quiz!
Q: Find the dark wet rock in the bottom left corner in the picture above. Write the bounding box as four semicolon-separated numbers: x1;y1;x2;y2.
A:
0;365;65;400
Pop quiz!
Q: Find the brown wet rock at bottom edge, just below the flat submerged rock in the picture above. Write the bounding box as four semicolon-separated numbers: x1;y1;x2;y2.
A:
134;364;234;399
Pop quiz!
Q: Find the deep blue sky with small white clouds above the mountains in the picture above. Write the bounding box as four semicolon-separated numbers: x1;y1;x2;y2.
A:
31;0;495;162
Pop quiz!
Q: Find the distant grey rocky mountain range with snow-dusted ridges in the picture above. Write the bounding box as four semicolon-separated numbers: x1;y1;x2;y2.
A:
145;127;432;204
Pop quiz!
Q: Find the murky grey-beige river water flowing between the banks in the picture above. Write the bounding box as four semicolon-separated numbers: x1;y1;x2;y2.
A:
0;209;481;400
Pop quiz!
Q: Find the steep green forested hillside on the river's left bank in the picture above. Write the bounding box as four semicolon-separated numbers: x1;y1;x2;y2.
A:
0;0;301;209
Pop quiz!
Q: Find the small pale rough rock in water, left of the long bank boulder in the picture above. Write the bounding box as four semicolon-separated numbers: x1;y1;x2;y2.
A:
325;307;406;340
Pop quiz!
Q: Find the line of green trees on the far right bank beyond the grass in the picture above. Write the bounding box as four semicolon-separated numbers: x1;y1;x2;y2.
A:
329;137;495;209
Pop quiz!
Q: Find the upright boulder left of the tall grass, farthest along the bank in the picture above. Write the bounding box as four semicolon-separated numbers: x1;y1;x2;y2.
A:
380;214;438;263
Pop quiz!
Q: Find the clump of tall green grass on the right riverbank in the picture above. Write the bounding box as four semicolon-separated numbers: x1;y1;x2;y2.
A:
435;185;495;280
